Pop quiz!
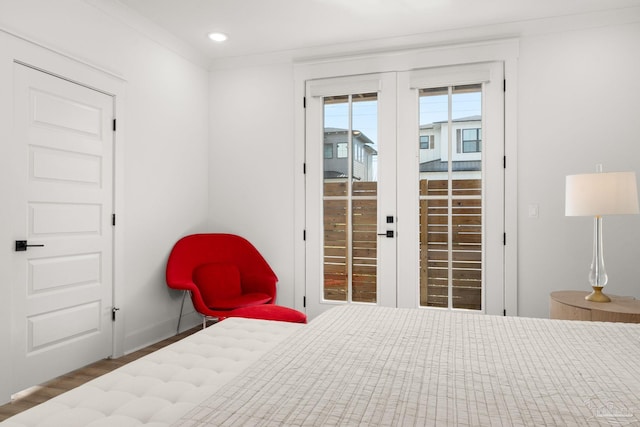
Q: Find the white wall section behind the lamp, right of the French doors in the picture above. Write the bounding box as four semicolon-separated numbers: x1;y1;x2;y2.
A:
518;21;640;316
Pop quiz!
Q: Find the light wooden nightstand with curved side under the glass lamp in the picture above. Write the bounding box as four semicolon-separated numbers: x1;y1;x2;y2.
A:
549;291;640;323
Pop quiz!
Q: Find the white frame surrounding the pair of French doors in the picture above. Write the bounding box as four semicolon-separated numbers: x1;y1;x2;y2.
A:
294;39;519;316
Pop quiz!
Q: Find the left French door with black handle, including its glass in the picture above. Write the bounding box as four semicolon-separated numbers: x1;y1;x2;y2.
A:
306;73;396;317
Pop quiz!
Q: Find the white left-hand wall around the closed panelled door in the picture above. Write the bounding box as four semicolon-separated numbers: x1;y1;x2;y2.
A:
0;0;209;401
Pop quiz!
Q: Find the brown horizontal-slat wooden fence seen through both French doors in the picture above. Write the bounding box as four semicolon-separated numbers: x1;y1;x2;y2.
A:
324;180;482;310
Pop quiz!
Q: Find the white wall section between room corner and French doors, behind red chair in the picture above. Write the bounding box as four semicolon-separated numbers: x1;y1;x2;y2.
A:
209;63;304;307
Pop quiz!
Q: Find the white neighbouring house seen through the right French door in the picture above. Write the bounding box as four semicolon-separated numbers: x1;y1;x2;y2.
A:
420;115;482;178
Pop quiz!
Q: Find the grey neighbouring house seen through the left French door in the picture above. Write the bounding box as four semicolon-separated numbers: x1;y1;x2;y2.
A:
324;128;378;182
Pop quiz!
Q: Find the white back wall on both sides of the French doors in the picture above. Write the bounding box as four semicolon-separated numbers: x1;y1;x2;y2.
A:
210;8;640;317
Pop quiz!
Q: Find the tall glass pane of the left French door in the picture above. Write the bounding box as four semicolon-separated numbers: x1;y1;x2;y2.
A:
323;93;378;303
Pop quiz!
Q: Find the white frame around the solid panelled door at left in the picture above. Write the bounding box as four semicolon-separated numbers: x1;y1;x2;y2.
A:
0;31;126;404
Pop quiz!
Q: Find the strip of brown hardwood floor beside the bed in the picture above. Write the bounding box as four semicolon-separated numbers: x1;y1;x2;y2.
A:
0;326;202;421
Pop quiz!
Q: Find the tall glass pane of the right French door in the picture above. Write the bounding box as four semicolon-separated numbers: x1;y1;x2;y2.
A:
416;84;482;310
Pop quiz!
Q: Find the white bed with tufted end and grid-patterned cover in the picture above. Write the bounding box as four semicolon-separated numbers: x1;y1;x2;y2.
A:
7;306;640;427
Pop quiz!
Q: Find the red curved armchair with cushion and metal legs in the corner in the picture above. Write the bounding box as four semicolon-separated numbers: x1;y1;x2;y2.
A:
167;233;278;331
